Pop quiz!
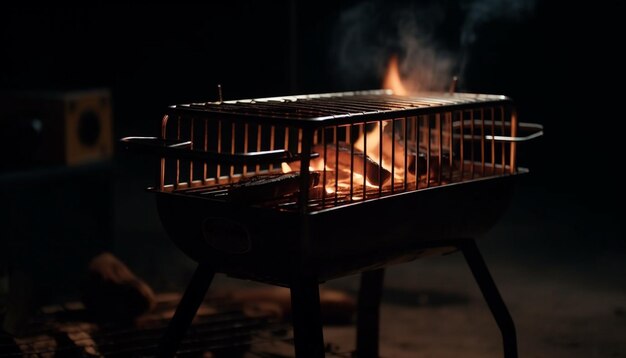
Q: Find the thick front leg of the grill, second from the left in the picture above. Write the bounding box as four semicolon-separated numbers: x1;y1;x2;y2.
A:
291;277;325;358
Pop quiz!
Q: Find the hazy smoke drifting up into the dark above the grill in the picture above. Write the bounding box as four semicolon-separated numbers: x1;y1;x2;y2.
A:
331;0;535;92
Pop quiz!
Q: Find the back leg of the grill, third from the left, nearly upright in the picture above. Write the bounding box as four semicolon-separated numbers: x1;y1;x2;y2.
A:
356;269;385;358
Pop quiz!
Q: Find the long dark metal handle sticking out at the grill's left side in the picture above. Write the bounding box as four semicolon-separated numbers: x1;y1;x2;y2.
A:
120;137;319;165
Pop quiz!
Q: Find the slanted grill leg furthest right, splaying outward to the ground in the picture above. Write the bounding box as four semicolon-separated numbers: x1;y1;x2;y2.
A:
458;240;517;358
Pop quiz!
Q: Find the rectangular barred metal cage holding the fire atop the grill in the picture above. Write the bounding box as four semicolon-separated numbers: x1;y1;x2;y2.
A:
155;90;519;212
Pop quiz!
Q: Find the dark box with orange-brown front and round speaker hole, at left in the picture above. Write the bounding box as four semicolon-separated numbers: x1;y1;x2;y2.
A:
0;89;113;169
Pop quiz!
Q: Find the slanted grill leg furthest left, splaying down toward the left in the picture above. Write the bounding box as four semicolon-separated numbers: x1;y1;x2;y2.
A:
158;263;215;358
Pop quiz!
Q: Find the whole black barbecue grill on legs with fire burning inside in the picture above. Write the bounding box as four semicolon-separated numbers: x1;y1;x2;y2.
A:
122;90;542;358
